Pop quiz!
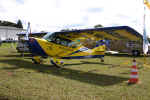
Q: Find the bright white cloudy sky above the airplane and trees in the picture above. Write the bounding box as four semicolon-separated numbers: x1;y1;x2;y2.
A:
0;0;150;36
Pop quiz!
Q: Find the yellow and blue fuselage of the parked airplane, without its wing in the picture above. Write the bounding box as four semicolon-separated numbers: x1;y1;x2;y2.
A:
29;32;105;59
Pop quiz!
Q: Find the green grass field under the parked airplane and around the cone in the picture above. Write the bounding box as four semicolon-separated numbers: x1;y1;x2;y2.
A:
0;44;150;100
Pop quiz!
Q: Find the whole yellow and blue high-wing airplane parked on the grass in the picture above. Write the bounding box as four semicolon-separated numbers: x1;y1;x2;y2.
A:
27;23;141;66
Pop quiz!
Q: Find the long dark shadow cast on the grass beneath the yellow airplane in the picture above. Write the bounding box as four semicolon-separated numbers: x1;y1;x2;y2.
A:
0;59;128;86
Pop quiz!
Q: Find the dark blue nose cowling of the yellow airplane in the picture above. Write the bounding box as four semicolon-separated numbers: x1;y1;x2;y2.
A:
28;37;47;57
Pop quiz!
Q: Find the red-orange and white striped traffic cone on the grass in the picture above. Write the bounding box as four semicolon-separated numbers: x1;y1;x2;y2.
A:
128;59;139;84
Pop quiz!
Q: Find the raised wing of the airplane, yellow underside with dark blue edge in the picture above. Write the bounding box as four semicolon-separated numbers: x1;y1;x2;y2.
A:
55;26;142;45
